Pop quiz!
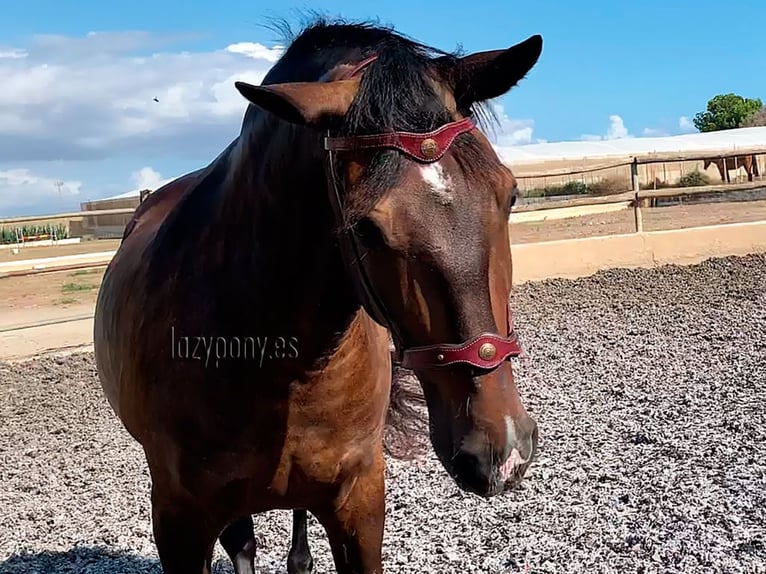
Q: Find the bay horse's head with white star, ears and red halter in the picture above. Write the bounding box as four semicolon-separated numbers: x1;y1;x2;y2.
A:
237;36;542;496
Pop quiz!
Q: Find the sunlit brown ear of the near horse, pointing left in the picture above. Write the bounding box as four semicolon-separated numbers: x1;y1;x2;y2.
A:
234;79;359;126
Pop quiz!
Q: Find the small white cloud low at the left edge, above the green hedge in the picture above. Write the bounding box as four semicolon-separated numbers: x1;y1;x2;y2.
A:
0;169;82;216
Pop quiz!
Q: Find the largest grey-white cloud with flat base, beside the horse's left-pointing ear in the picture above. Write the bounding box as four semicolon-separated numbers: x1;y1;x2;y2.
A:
0;32;282;162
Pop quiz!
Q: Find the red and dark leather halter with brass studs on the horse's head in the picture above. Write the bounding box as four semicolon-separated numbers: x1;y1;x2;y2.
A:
324;55;522;370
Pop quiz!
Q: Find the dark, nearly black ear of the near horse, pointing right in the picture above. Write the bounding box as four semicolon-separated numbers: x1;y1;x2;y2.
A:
437;34;543;107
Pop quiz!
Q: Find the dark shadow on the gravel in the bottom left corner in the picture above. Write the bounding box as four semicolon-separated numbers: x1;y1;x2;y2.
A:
0;546;260;574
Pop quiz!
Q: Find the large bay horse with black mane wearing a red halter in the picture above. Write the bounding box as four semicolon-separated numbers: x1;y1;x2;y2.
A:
94;19;542;574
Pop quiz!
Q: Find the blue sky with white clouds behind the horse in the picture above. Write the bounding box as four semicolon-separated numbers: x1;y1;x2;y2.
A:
0;0;766;217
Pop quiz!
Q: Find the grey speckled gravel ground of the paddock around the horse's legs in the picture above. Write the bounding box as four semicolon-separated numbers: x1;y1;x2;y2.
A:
0;256;766;574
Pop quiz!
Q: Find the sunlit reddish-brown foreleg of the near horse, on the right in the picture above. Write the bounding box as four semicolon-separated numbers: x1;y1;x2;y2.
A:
311;454;386;574
